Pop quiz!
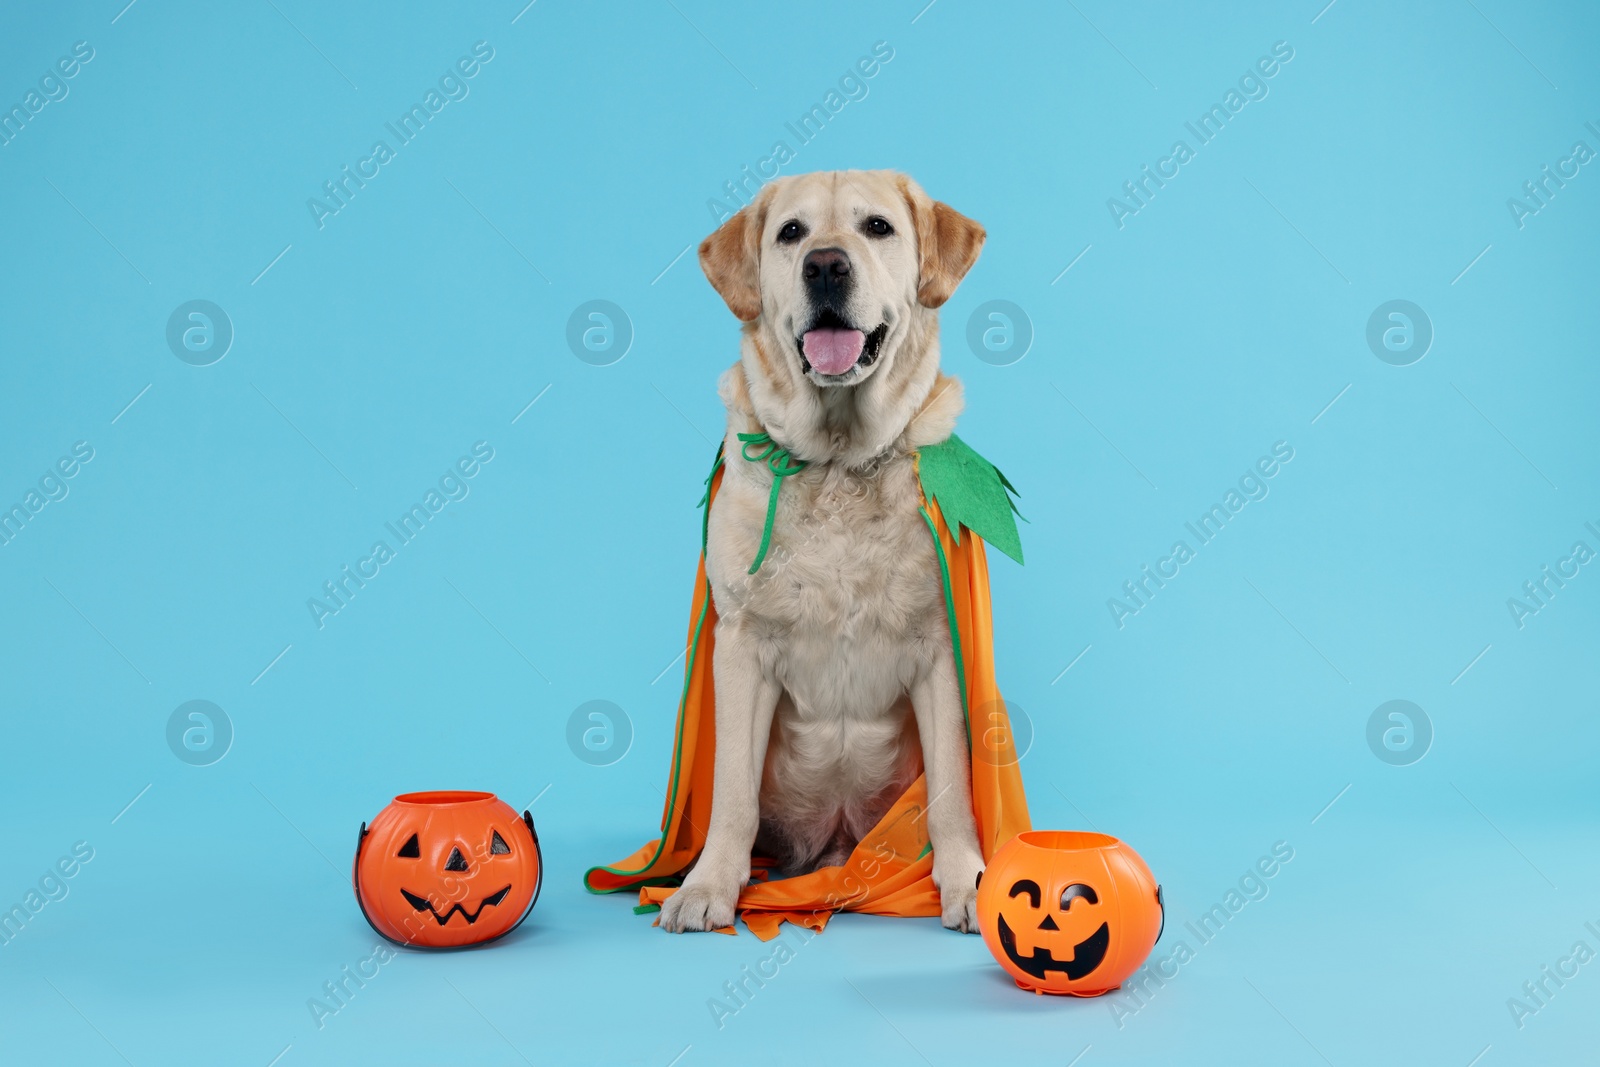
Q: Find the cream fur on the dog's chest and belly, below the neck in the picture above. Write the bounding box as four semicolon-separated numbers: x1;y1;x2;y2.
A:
707;450;949;864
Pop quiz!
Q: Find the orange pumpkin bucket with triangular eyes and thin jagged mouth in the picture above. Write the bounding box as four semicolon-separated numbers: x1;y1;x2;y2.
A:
352;790;544;949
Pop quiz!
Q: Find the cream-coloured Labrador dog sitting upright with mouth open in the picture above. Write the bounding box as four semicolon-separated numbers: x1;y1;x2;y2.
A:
661;171;984;933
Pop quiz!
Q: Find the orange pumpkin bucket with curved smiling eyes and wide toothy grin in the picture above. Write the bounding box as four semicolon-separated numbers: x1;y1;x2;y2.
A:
978;830;1165;997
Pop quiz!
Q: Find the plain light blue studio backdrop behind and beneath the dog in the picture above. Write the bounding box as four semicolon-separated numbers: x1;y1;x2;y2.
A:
0;0;1600;1067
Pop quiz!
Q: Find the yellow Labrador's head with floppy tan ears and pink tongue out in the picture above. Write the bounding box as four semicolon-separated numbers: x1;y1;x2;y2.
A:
699;171;984;389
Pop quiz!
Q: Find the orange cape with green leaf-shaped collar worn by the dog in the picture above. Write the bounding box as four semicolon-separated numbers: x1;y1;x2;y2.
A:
584;435;1029;941
